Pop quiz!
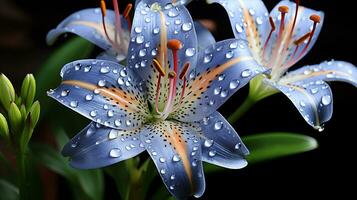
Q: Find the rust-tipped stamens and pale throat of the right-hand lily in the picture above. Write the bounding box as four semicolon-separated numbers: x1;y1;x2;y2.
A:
262;0;321;80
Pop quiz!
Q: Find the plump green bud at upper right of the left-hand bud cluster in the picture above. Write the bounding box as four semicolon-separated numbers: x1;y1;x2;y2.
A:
20;74;36;109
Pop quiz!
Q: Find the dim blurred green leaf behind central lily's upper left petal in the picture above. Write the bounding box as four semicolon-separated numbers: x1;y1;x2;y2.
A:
35;37;94;117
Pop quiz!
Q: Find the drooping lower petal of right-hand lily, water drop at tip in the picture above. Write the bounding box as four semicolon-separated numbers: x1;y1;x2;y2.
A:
268;80;333;130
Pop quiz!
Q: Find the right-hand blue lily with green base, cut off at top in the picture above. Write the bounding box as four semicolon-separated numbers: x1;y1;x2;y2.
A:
210;0;357;131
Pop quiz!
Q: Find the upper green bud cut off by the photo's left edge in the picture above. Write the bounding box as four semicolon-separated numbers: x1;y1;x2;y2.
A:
0;74;15;110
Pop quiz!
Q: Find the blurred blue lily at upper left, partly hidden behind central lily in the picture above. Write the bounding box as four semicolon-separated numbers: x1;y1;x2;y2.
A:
47;0;132;61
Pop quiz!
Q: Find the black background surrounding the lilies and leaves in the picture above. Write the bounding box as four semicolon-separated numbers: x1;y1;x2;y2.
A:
0;0;357;199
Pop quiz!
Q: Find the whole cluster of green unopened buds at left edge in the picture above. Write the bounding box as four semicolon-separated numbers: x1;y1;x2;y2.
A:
0;74;40;150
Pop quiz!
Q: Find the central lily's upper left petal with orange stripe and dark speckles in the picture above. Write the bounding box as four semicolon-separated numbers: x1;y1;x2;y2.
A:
48;60;148;129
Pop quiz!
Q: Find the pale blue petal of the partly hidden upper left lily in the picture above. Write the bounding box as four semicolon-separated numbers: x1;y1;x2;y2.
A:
47;8;129;53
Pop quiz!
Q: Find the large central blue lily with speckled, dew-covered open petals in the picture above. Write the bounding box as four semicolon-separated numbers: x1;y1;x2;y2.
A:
48;2;265;199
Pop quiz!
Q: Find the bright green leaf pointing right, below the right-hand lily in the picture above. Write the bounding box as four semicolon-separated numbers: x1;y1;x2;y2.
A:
243;132;318;163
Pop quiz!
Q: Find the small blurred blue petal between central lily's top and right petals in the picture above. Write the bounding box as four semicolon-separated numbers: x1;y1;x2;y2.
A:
194;21;216;51
